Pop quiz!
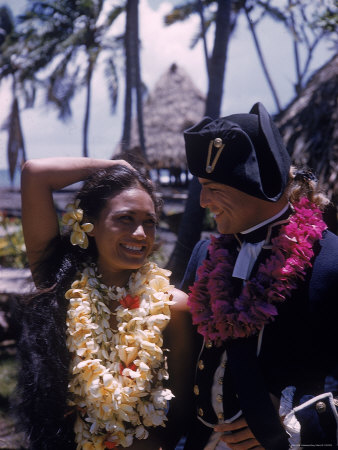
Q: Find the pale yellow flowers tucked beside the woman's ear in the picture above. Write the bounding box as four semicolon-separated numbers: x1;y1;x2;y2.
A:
61;199;94;248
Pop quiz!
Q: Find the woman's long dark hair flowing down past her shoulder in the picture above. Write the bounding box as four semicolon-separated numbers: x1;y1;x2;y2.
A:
16;165;161;450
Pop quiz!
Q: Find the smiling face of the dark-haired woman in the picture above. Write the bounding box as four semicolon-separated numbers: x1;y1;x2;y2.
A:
90;188;156;284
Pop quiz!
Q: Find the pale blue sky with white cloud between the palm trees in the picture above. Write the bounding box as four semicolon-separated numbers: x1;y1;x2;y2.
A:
0;0;332;169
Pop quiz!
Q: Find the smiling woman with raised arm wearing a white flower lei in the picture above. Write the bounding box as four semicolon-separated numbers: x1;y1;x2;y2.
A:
18;158;191;450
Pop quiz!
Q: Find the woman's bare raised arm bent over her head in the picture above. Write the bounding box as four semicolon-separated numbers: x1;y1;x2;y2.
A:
21;158;129;272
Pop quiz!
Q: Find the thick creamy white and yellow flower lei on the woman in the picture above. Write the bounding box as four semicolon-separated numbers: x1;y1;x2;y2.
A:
65;262;174;450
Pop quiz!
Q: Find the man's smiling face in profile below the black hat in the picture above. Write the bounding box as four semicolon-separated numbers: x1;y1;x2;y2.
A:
199;178;267;234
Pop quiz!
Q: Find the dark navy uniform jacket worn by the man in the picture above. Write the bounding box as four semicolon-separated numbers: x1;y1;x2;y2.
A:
181;231;338;450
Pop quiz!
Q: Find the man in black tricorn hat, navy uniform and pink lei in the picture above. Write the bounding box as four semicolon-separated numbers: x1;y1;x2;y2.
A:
182;103;338;450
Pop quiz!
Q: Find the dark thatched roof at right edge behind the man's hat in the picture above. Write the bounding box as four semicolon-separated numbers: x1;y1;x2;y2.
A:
276;55;338;204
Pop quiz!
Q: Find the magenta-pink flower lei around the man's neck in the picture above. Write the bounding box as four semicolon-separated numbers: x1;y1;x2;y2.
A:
188;197;327;346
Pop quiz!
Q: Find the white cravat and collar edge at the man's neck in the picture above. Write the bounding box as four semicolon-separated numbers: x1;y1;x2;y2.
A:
232;204;289;280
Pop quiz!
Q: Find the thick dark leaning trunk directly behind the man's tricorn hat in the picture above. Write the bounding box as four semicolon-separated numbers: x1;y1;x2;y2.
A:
167;0;231;284
